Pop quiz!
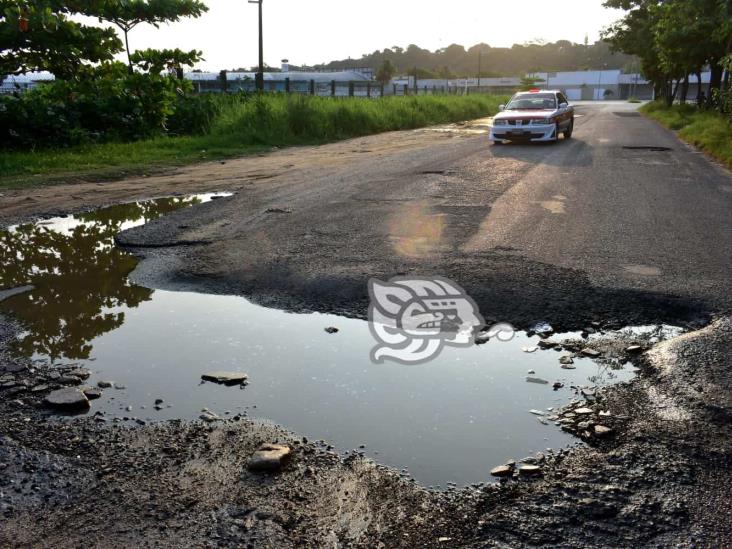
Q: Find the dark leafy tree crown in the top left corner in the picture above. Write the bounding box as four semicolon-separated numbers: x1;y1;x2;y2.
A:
0;0;122;79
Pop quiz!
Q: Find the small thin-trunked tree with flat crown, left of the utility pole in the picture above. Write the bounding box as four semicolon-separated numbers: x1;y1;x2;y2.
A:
98;0;208;73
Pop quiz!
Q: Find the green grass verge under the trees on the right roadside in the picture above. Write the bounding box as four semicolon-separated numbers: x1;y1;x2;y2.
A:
640;102;732;168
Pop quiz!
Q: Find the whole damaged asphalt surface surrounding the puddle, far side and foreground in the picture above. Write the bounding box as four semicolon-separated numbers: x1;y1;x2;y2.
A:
0;103;732;547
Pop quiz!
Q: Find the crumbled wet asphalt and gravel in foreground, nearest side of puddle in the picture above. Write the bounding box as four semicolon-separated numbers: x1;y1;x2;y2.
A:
0;312;732;547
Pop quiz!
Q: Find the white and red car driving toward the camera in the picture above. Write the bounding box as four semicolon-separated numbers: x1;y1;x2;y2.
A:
490;90;574;145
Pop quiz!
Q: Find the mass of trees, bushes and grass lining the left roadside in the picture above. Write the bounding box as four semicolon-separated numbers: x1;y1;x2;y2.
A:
0;0;505;187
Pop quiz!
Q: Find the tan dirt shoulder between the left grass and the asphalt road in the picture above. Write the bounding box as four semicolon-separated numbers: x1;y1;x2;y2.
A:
0;120;486;226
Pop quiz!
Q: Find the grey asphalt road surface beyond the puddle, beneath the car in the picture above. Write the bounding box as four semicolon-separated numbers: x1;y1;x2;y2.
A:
120;102;732;329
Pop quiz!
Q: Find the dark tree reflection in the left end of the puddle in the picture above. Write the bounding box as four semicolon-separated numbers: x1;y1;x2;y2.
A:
0;195;222;360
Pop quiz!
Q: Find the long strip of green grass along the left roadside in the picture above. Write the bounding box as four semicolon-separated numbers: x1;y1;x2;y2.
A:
0;95;506;188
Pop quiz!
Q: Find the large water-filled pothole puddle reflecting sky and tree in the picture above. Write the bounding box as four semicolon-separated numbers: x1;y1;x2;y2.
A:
0;195;676;488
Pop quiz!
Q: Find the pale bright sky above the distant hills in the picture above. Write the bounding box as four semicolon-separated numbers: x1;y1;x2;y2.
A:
116;0;622;71
